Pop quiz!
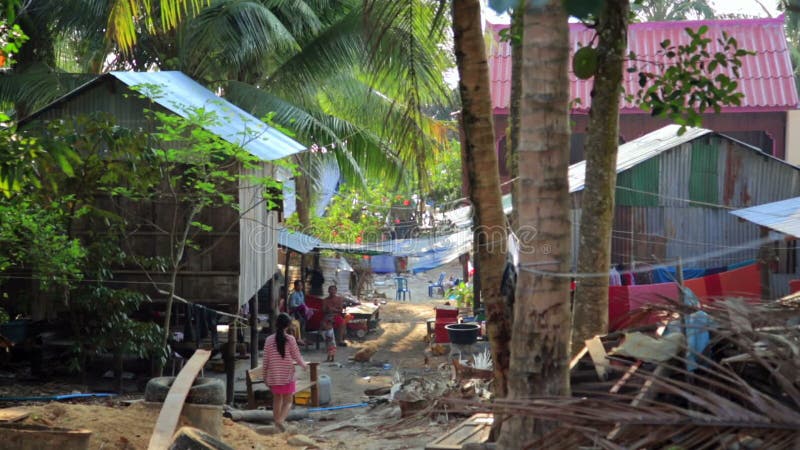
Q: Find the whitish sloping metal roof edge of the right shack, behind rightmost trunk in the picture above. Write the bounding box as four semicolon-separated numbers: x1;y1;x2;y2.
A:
569;125;713;193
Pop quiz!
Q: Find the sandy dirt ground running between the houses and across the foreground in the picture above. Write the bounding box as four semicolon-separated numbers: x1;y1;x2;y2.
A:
0;264;476;450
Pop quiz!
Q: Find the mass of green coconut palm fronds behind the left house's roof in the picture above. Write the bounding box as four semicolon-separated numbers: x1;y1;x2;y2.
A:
0;0;456;204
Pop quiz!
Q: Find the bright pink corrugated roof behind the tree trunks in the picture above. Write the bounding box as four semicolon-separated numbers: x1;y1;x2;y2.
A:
488;16;800;113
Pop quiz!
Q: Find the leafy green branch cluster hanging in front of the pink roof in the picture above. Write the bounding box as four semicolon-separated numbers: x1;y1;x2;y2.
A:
628;25;753;134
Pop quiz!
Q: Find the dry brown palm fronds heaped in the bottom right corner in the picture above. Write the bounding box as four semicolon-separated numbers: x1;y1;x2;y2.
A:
440;299;800;449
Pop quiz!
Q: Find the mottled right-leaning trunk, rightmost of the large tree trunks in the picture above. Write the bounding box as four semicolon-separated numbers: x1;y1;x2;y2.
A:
572;0;629;352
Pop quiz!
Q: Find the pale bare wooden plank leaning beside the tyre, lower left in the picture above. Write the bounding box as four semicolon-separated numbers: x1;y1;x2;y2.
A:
147;350;211;450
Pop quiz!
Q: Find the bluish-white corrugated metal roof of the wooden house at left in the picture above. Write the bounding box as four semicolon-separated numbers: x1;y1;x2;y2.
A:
110;71;305;161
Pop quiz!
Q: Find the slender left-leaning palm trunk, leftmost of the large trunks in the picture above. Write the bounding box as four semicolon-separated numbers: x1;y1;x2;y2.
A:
452;0;511;397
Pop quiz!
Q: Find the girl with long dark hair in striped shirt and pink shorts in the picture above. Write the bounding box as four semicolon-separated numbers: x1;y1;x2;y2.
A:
263;313;308;431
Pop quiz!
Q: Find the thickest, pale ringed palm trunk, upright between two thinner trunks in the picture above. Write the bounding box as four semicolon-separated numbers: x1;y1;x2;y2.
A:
498;0;571;449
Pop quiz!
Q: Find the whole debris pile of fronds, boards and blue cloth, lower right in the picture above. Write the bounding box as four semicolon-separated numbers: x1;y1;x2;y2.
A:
427;292;800;449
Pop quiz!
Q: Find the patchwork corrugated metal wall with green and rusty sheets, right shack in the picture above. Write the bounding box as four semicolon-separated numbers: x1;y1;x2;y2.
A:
572;135;800;293
